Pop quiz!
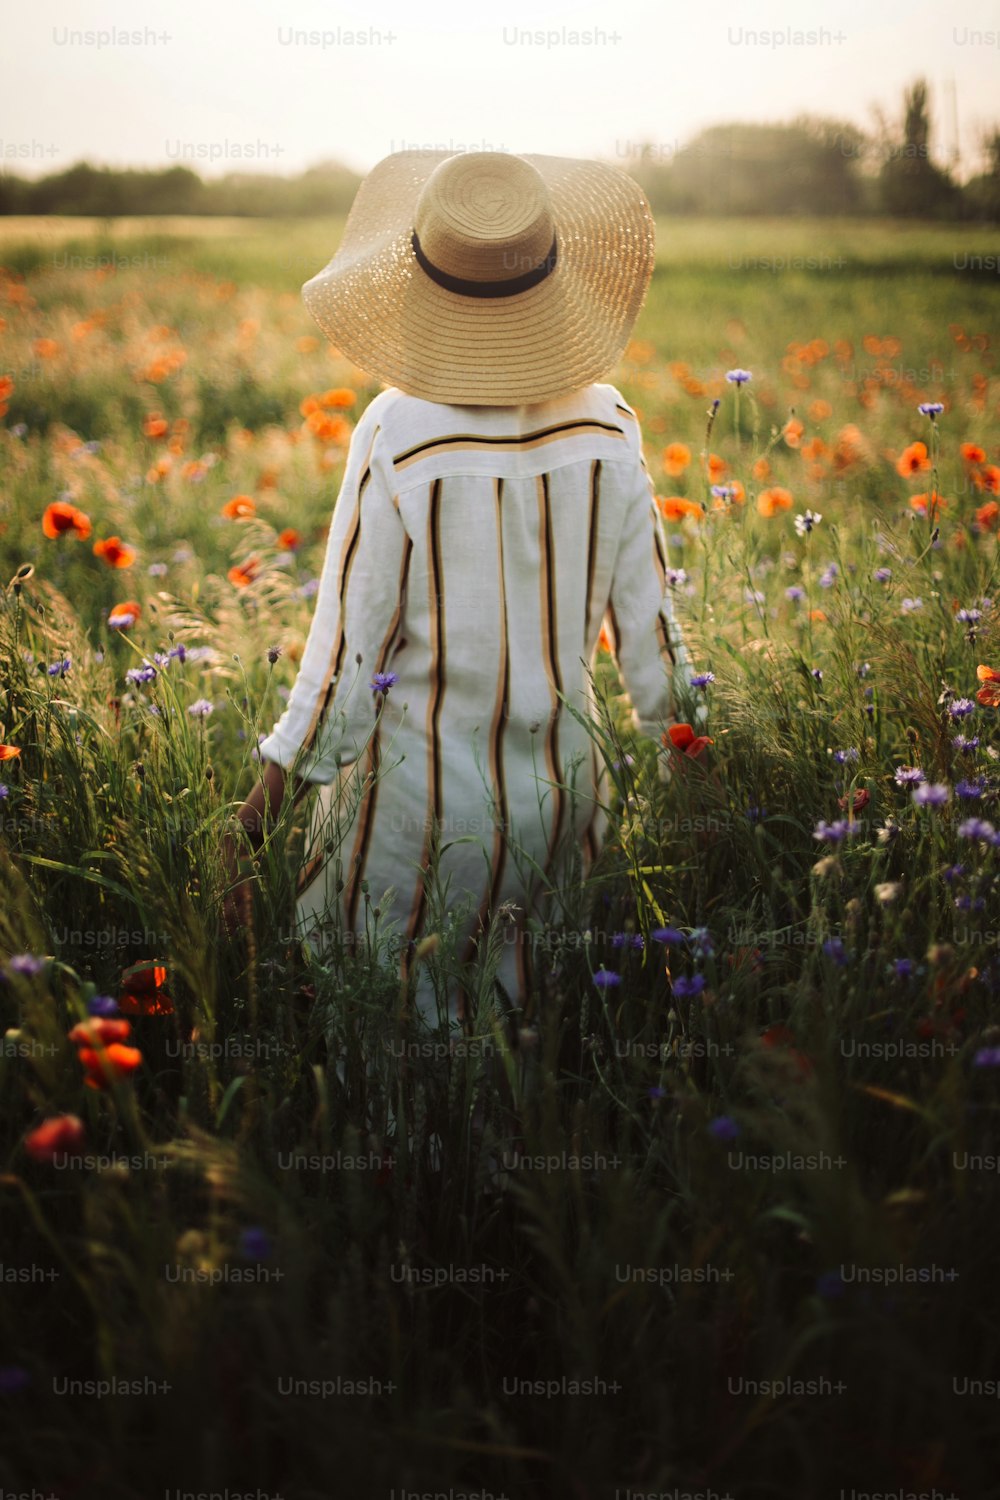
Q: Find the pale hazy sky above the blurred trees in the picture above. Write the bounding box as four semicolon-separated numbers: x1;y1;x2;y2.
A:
0;0;1000;176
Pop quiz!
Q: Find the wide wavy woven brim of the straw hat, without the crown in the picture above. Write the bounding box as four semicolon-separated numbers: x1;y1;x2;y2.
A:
303;152;655;407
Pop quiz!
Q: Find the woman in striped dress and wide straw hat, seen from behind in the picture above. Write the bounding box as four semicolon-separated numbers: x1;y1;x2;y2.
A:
229;143;701;1032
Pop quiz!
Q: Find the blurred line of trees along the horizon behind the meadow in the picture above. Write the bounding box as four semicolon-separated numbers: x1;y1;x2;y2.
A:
0;80;1000;222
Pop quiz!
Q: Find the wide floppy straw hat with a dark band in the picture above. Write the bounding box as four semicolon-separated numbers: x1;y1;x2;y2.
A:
303;152;655;407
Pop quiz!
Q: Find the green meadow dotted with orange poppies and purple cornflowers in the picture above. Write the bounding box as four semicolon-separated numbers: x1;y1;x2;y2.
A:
0;221;1000;1500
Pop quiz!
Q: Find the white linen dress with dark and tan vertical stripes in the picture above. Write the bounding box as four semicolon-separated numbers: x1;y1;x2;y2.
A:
259;384;688;1014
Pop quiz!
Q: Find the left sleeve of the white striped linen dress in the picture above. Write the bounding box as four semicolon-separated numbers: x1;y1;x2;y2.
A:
258;417;411;783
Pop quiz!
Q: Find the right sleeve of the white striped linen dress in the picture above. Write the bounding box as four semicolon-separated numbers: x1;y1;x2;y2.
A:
607;422;701;743
